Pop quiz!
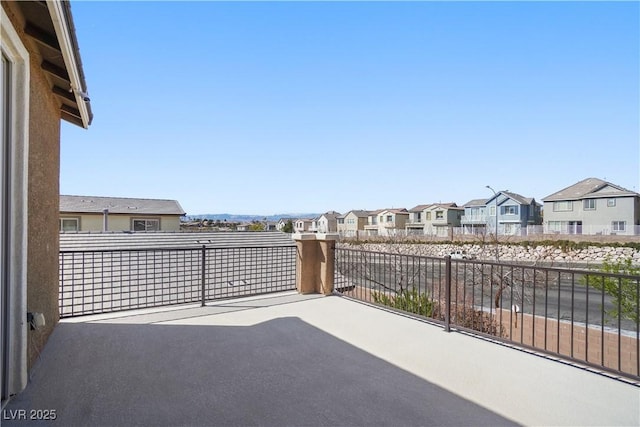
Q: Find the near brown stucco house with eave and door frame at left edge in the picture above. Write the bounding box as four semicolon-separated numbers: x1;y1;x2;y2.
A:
0;1;93;406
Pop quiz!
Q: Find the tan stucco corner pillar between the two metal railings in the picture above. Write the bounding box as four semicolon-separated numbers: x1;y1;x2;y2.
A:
293;233;338;295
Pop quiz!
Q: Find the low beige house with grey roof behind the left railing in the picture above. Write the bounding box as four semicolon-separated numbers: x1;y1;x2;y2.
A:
60;196;185;232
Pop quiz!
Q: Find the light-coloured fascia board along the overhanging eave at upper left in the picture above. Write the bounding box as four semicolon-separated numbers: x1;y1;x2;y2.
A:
47;0;89;129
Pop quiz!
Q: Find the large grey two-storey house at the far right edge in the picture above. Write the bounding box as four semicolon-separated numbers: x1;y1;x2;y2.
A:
542;178;640;234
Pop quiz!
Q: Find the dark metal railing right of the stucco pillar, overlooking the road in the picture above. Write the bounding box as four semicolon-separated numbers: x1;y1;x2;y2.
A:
335;248;640;380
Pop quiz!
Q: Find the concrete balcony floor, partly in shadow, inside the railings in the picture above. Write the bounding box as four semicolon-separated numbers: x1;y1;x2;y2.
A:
2;293;640;426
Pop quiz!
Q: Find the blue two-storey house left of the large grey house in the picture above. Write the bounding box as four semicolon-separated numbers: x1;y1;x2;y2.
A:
461;191;542;235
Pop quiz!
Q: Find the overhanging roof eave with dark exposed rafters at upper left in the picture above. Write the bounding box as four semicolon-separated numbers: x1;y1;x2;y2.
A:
15;0;93;128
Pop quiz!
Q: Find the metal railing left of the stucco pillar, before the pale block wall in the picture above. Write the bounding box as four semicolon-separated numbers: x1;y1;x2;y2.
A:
59;246;296;317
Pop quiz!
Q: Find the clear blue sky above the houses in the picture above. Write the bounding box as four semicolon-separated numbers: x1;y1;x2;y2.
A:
60;1;640;215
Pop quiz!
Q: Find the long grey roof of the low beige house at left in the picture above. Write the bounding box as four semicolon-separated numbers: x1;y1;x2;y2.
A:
60;195;185;216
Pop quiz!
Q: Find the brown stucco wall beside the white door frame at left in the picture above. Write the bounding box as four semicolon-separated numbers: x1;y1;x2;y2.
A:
2;2;60;368
